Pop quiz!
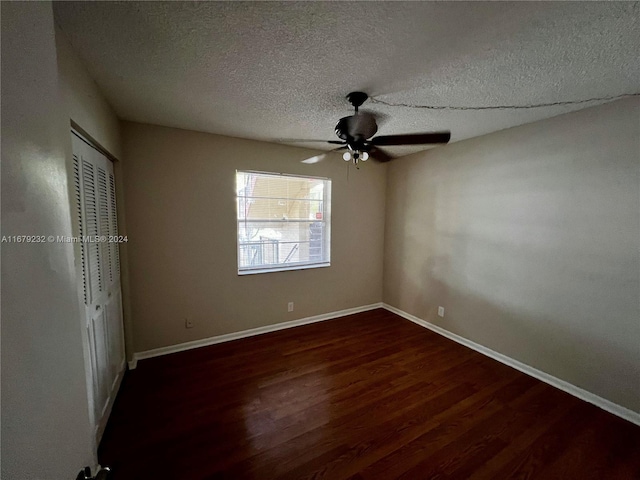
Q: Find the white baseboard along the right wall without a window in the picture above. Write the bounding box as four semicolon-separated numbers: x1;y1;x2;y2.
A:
382;303;640;426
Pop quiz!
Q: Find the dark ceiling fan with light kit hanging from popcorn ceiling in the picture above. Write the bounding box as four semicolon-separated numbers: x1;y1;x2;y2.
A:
302;92;451;166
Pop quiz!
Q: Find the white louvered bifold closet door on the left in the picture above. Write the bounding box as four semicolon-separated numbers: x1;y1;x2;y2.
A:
72;134;125;440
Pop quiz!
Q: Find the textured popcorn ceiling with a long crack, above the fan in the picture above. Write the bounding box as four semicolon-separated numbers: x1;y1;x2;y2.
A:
54;2;640;154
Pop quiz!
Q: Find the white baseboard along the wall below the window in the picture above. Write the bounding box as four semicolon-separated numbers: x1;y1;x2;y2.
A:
129;303;382;370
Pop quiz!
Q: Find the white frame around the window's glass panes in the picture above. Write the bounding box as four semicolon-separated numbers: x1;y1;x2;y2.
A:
234;170;331;275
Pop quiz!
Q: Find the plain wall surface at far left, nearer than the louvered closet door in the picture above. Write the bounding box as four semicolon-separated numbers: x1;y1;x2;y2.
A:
1;2;95;480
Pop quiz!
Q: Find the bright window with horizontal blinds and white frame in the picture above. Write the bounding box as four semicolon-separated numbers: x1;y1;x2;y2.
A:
236;171;331;275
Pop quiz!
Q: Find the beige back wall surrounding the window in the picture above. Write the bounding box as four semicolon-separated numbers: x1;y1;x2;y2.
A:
123;123;386;352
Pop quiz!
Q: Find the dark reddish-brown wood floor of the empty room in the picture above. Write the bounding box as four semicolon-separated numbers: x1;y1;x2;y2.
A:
99;310;640;480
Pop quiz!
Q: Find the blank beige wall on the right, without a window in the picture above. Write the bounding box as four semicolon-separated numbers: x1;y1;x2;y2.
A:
384;99;640;412
